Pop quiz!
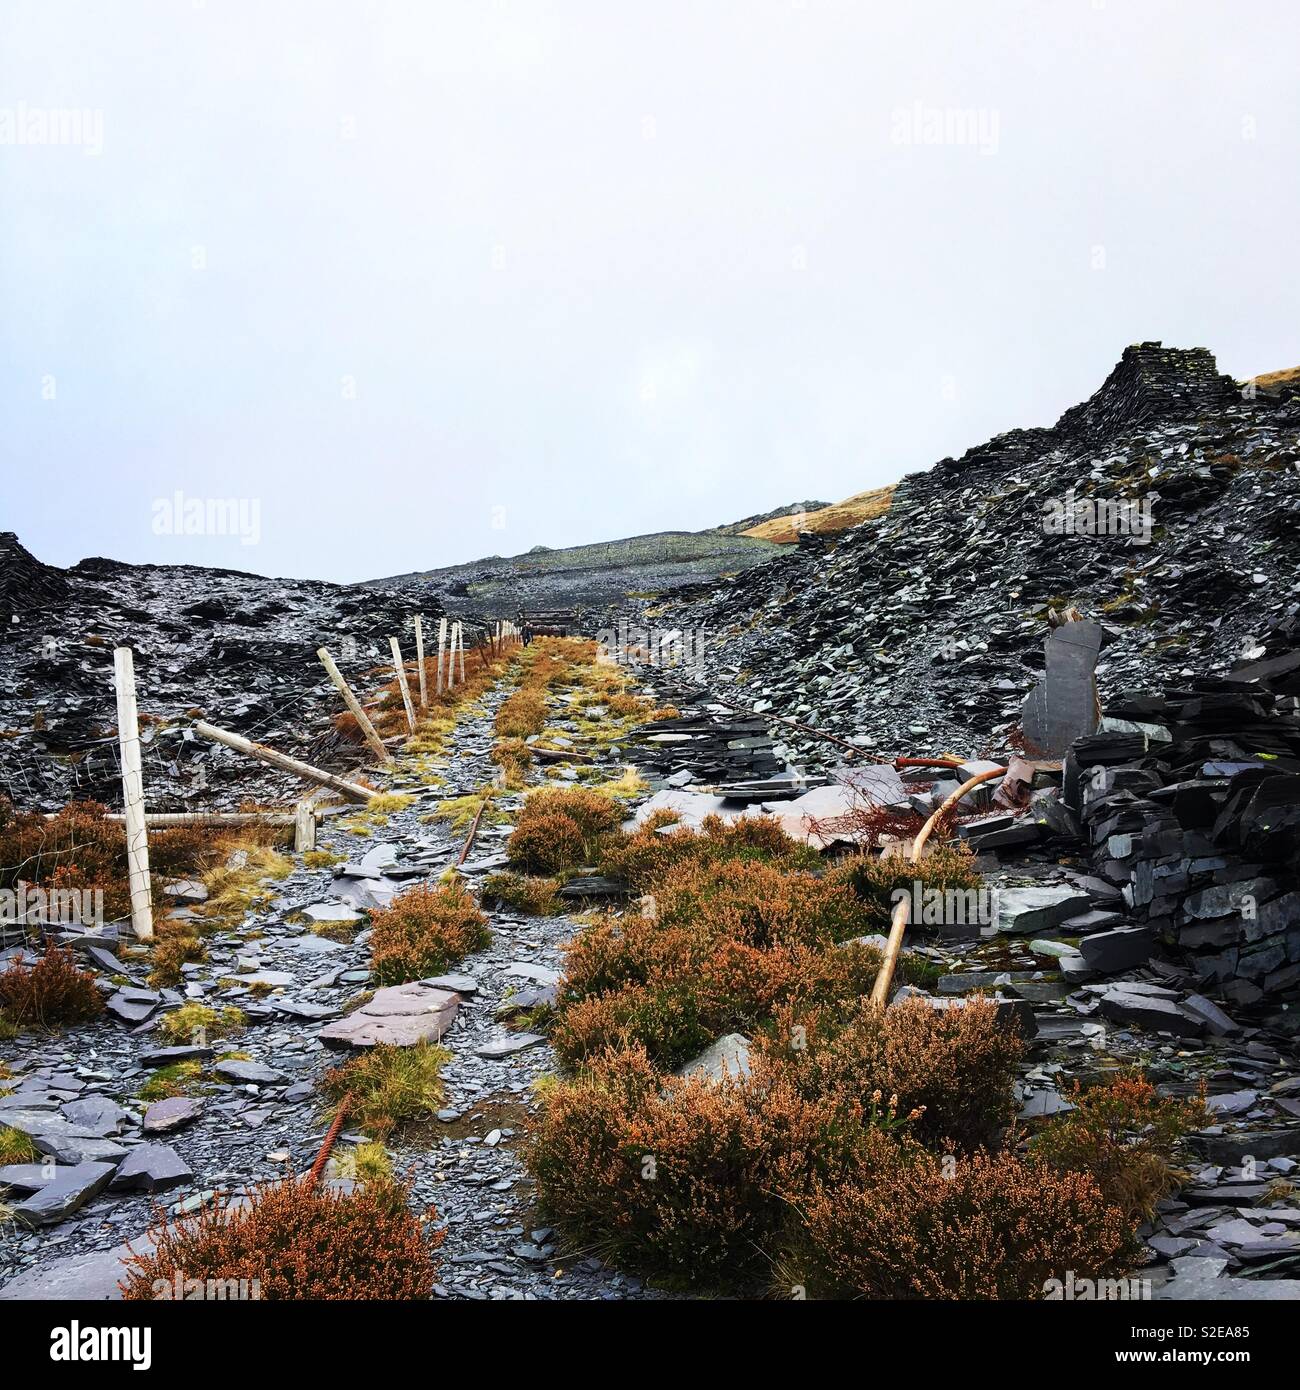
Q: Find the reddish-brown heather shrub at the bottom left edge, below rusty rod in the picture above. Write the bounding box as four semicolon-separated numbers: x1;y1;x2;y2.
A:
121;1179;442;1301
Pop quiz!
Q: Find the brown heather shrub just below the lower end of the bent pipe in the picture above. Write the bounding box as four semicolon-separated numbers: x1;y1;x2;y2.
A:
766;998;1023;1152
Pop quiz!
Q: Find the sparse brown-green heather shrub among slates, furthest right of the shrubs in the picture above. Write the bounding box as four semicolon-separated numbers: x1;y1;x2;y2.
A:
1029;1072;1210;1222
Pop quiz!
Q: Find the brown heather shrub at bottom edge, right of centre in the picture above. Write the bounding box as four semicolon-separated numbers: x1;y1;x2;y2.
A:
802;1144;1133;1300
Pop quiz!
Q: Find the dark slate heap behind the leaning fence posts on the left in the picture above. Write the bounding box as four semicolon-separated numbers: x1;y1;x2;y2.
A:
0;532;458;810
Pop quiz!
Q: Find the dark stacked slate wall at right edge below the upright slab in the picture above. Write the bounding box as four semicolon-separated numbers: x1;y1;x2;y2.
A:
1062;613;1300;1005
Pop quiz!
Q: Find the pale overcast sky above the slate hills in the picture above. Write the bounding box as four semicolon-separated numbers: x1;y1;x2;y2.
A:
0;0;1300;581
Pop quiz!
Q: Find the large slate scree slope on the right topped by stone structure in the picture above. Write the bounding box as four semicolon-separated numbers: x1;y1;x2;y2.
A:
653;343;1300;766
